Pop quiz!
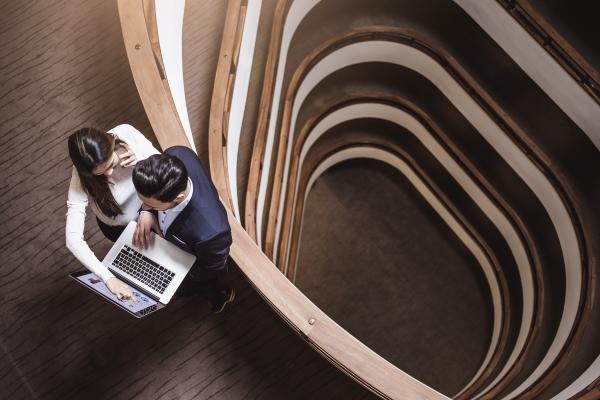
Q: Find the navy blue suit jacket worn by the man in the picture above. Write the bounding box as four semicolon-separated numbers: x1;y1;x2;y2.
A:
163;146;232;278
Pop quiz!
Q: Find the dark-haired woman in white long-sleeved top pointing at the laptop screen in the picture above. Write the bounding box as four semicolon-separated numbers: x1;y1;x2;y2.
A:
66;125;159;301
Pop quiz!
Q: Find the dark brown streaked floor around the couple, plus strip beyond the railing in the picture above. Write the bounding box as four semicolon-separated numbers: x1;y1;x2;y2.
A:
0;0;372;399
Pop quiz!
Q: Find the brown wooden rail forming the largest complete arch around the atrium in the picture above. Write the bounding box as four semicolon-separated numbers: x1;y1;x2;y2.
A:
265;27;594;397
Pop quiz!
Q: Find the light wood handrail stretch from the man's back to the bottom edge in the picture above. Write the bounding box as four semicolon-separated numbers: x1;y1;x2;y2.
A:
228;205;446;399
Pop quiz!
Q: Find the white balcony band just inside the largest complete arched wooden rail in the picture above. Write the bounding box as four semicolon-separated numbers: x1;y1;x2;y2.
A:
274;40;582;400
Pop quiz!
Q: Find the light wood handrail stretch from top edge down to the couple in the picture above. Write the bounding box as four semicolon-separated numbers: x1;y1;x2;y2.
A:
118;0;190;148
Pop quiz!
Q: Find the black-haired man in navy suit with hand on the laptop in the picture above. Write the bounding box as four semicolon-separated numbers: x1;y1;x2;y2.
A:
132;146;235;312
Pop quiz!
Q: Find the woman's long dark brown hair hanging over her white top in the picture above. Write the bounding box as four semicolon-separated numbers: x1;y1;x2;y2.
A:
68;127;123;218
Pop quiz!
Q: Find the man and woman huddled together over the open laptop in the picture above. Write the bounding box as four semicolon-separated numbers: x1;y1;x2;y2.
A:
66;125;235;312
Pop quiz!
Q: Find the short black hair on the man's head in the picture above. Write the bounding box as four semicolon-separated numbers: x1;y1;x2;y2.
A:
132;154;188;203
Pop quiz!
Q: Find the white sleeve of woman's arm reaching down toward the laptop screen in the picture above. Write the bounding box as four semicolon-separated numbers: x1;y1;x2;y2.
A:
66;170;114;283
